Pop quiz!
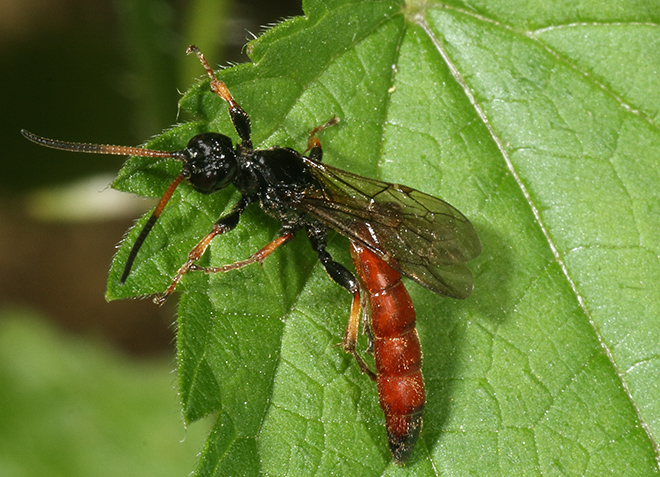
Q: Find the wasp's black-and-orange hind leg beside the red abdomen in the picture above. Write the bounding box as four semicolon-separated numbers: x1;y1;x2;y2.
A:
307;225;376;381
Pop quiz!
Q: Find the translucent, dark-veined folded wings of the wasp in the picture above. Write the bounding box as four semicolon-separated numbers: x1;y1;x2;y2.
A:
297;158;481;298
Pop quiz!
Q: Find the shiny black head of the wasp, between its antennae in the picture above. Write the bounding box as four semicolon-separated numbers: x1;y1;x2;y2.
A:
182;133;238;194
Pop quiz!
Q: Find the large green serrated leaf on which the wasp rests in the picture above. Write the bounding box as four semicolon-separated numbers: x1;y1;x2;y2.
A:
103;0;660;475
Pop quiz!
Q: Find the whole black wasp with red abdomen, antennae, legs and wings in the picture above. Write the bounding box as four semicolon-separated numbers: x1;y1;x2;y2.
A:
22;46;481;464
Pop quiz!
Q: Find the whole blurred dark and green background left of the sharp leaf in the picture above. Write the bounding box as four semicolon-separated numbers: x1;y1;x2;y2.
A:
0;0;302;476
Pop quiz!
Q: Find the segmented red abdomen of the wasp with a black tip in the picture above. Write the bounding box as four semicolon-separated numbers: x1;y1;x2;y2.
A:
351;243;425;463
